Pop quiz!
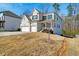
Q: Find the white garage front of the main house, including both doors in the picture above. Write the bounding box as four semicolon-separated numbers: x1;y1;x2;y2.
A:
20;16;37;32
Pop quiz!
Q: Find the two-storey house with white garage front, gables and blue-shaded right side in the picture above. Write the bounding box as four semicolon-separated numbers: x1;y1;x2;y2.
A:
20;9;62;34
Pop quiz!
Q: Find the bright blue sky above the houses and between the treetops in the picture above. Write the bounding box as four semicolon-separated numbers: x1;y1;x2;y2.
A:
0;3;68;15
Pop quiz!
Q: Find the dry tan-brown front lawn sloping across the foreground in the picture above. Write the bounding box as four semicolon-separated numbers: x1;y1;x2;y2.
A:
0;32;79;56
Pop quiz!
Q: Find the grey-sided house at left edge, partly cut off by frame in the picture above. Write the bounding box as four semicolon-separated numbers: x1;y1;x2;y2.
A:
0;11;21;31
